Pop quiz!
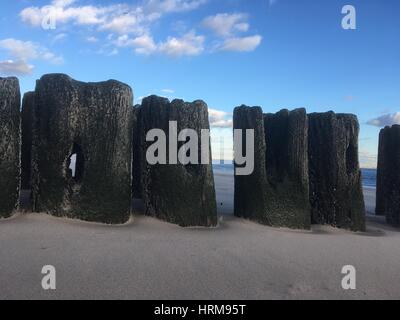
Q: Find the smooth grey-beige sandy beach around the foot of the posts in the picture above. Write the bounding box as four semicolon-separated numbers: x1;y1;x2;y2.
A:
0;174;400;299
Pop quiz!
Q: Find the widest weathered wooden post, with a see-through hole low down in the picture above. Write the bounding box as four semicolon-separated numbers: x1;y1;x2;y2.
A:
32;74;133;224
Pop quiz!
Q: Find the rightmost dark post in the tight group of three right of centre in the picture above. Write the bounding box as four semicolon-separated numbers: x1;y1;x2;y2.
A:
308;112;365;231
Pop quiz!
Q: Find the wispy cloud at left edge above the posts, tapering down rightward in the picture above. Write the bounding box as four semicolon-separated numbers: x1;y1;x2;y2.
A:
0;38;64;64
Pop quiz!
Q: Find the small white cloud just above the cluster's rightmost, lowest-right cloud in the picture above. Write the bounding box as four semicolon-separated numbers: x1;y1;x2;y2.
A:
202;13;250;37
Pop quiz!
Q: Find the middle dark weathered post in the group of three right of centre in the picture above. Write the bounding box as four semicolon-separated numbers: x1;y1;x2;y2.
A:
264;109;311;229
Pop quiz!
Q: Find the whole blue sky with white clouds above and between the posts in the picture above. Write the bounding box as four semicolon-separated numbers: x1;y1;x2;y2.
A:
0;0;400;167
